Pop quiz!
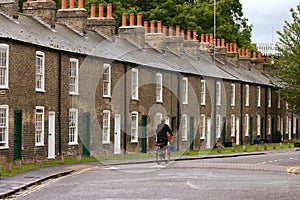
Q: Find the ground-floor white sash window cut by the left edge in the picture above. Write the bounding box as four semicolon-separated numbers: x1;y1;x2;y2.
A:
0;105;9;149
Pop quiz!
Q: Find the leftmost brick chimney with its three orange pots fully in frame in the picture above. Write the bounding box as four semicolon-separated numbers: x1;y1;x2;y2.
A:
87;3;116;37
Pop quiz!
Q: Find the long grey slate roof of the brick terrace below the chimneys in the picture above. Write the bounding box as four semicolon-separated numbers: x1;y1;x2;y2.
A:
0;11;269;85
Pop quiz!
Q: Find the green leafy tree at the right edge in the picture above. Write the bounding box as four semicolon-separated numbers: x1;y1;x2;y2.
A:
276;4;300;114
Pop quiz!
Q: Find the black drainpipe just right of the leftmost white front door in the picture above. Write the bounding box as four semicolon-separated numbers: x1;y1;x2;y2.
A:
57;52;62;156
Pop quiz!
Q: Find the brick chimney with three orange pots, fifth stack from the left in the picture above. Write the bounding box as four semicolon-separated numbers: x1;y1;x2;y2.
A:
119;13;144;48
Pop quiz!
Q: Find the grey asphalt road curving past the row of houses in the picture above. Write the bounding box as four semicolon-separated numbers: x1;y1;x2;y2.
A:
15;152;300;200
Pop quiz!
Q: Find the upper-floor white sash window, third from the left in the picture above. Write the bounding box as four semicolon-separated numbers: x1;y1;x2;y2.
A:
69;58;79;95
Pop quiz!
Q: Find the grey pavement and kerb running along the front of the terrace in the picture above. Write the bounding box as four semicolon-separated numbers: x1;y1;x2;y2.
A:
0;148;300;199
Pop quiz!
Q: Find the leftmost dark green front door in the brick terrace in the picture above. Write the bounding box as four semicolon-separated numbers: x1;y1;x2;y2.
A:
14;110;22;161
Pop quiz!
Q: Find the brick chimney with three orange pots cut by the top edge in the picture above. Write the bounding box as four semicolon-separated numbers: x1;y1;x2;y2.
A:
56;0;87;33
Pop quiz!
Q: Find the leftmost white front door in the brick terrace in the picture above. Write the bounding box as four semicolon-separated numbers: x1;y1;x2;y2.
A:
48;111;55;159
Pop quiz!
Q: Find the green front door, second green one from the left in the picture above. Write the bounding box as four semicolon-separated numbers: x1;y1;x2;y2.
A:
82;112;90;156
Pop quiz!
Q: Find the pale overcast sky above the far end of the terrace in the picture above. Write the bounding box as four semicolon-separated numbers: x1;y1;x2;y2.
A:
240;0;300;43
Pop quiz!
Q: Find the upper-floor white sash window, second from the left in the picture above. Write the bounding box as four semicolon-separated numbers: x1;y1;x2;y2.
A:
35;51;45;92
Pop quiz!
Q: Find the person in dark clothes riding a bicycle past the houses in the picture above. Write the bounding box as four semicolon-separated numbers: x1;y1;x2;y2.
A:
156;118;173;159
